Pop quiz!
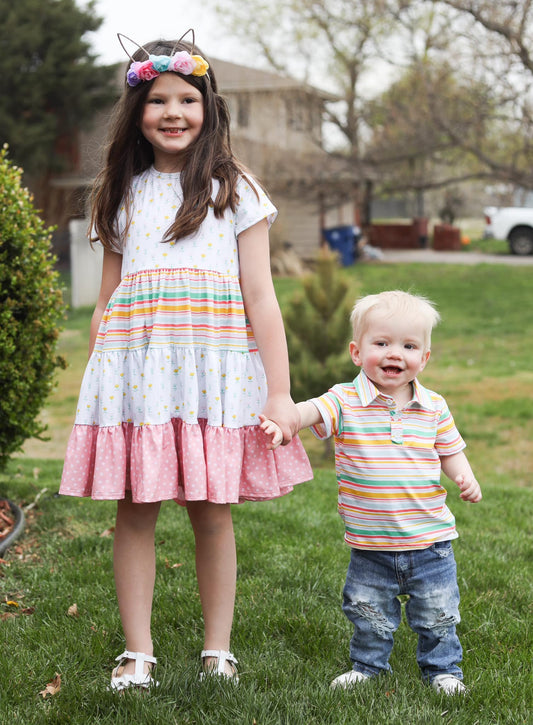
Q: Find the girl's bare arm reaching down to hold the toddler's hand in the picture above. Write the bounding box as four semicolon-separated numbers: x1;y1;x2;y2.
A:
239;219;300;443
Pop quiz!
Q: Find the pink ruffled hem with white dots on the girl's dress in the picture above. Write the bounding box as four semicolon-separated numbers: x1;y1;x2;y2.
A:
60;418;313;504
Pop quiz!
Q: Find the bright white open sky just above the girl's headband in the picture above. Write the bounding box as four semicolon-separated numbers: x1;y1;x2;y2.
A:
85;0;245;65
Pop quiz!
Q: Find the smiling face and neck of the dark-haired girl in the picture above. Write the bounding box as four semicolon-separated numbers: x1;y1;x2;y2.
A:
141;73;204;172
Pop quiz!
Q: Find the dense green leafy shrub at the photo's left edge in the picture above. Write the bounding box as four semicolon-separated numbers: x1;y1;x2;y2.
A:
0;146;64;470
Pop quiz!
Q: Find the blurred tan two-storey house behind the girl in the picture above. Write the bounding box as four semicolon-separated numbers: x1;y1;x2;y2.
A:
53;60;366;257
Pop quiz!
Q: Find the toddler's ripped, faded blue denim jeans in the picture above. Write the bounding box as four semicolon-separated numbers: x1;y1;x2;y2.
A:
342;541;463;681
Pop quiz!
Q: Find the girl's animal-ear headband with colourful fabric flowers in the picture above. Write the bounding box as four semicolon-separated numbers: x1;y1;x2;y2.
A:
117;28;209;88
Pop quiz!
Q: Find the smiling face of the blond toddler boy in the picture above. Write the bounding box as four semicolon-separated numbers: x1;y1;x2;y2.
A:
350;310;430;399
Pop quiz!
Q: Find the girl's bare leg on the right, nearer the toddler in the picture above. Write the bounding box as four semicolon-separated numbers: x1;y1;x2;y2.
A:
187;501;237;674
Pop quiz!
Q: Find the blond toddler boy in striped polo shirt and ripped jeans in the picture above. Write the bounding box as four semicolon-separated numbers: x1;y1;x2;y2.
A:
261;290;481;695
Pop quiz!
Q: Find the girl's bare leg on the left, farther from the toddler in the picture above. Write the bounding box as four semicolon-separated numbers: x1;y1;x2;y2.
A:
113;498;161;674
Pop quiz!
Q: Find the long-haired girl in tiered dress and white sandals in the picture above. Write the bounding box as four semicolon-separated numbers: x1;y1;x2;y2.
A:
60;31;312;690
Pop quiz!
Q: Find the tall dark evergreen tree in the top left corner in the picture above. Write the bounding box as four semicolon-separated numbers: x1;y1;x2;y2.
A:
0;0;115;177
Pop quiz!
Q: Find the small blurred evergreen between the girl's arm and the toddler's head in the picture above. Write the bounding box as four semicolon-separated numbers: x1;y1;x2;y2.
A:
284;250;357;401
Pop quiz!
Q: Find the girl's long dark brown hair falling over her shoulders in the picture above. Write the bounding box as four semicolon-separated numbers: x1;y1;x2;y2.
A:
91;40;245;250
